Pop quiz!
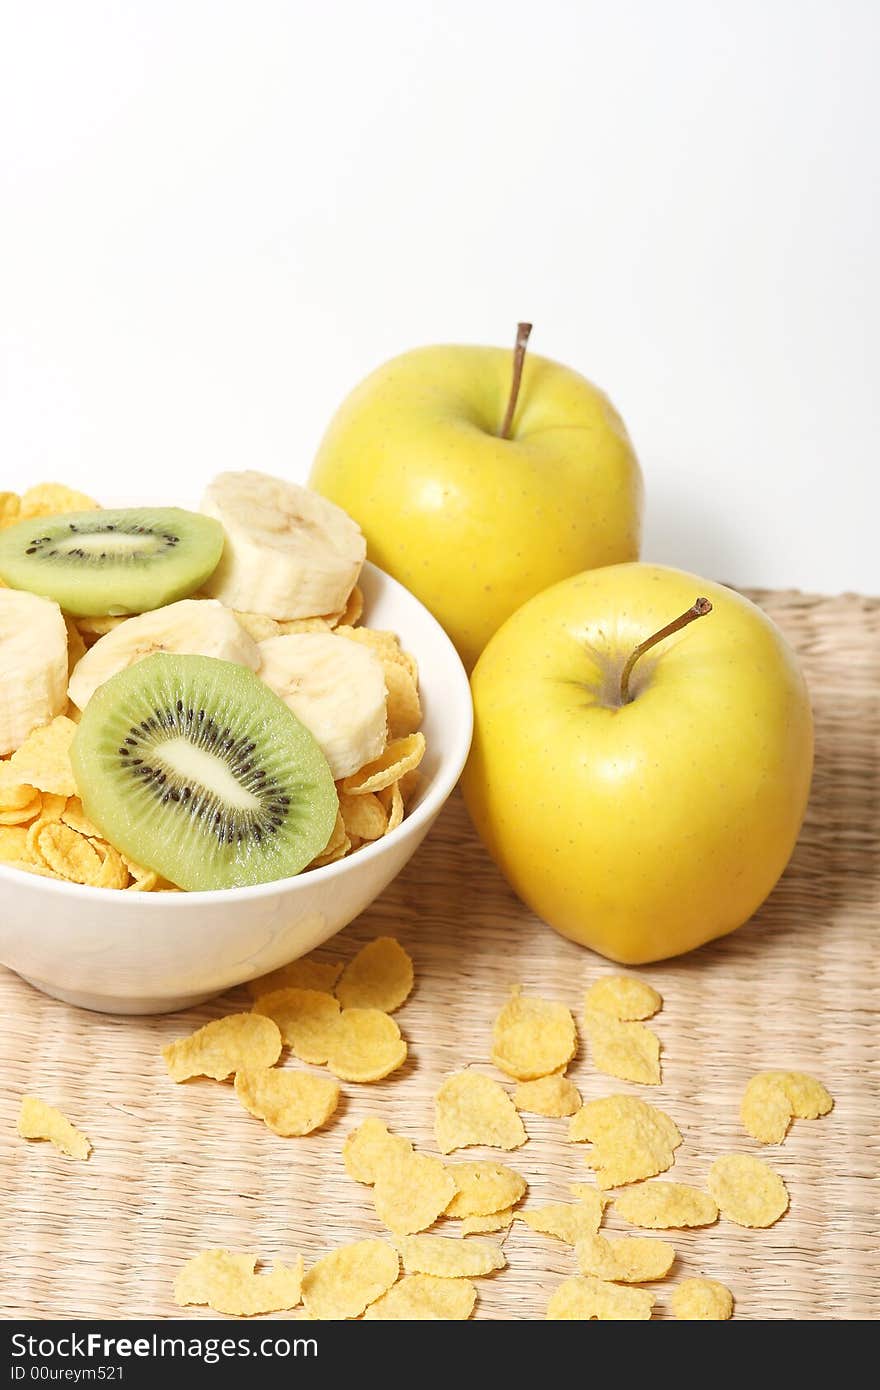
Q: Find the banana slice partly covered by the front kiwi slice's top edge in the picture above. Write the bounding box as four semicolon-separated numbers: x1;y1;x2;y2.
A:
68;599;260;709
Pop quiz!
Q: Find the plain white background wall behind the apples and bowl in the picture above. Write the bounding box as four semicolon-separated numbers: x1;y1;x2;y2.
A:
0;0;880;592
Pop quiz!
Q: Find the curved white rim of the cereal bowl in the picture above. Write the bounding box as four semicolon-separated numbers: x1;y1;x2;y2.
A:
0;560;474;912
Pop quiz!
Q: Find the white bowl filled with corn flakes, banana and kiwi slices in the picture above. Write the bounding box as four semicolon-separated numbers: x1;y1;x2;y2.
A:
0;475;471;1012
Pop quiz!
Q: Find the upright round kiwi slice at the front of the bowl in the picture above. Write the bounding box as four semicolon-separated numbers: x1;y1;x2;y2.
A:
71;653;339;890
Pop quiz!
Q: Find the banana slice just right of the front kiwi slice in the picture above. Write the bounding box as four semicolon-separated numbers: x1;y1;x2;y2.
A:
260;632;386;781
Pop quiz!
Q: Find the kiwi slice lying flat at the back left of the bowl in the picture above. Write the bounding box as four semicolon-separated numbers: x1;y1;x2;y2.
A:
0;507;224;617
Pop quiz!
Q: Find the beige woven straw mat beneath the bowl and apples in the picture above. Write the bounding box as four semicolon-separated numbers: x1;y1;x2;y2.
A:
0;592;880;1319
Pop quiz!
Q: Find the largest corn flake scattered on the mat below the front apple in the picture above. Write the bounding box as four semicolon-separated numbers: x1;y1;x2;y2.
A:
569;1095;681;1188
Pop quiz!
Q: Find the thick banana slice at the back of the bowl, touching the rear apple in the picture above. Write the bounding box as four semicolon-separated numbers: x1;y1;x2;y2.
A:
202;473;367;621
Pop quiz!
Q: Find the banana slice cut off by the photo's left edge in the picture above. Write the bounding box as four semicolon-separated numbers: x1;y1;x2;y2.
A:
0;589;67;756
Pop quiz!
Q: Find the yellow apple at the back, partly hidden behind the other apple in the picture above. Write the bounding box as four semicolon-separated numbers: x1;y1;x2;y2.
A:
310;325;642;667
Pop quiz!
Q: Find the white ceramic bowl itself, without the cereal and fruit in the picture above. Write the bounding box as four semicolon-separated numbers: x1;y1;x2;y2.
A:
0;564;473;1013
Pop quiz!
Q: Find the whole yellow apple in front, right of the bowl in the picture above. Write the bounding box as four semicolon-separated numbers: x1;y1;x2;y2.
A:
463;564;813;965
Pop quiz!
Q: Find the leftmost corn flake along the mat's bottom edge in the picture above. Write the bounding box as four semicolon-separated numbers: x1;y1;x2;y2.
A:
174;1250;303;1318
